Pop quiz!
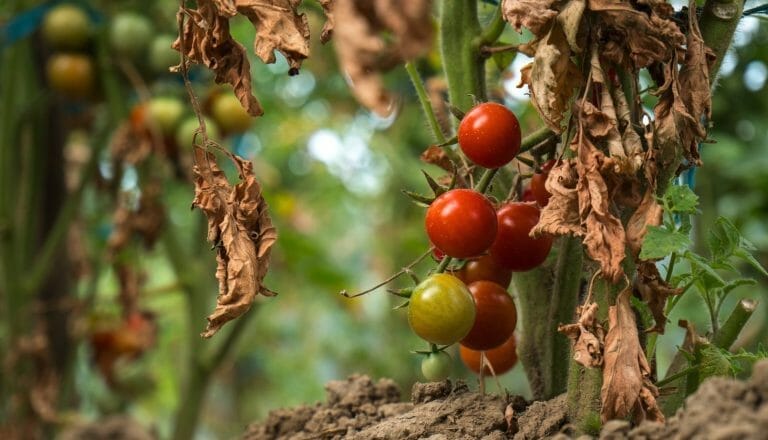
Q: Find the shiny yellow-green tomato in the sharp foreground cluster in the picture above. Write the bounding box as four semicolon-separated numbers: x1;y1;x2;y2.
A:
408;273;476;345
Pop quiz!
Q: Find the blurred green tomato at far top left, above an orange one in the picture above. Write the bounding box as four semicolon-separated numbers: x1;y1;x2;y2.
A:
42;4;91;49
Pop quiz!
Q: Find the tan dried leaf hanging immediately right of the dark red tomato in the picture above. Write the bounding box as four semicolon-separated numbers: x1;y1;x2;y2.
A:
531;161;585;236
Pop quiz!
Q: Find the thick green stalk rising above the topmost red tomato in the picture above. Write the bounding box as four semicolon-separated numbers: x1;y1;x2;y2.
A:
439;0;487;111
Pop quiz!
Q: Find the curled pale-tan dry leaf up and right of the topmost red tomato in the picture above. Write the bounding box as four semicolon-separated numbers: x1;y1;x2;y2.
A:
518;25;581;133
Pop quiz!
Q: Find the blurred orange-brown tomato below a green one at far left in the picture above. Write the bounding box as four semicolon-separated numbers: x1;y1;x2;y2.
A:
45;53;95;98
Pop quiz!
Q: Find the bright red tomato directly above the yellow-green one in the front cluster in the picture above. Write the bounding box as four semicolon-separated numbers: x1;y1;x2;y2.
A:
425;189;496;258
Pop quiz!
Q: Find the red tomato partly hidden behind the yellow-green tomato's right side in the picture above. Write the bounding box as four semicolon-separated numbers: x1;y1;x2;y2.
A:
461;281;517;350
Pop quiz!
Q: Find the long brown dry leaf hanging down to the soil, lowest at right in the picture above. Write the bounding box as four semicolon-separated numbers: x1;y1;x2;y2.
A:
600;288;664;423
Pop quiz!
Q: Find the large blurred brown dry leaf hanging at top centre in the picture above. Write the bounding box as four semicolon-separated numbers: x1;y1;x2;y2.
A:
334;0;433;115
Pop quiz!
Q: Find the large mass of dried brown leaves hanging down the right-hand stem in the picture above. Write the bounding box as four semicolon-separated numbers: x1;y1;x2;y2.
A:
502;0;713;421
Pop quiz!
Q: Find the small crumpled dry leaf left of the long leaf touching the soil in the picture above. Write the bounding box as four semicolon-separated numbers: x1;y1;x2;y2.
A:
557;302;605;368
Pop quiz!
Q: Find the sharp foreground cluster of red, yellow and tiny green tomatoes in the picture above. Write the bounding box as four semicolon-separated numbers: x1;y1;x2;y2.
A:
408;103;552;380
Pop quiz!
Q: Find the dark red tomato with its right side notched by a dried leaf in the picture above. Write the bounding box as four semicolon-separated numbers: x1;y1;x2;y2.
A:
491;202;552;272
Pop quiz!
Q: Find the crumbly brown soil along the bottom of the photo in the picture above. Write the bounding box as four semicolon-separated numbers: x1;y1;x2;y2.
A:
244;361;768;440
